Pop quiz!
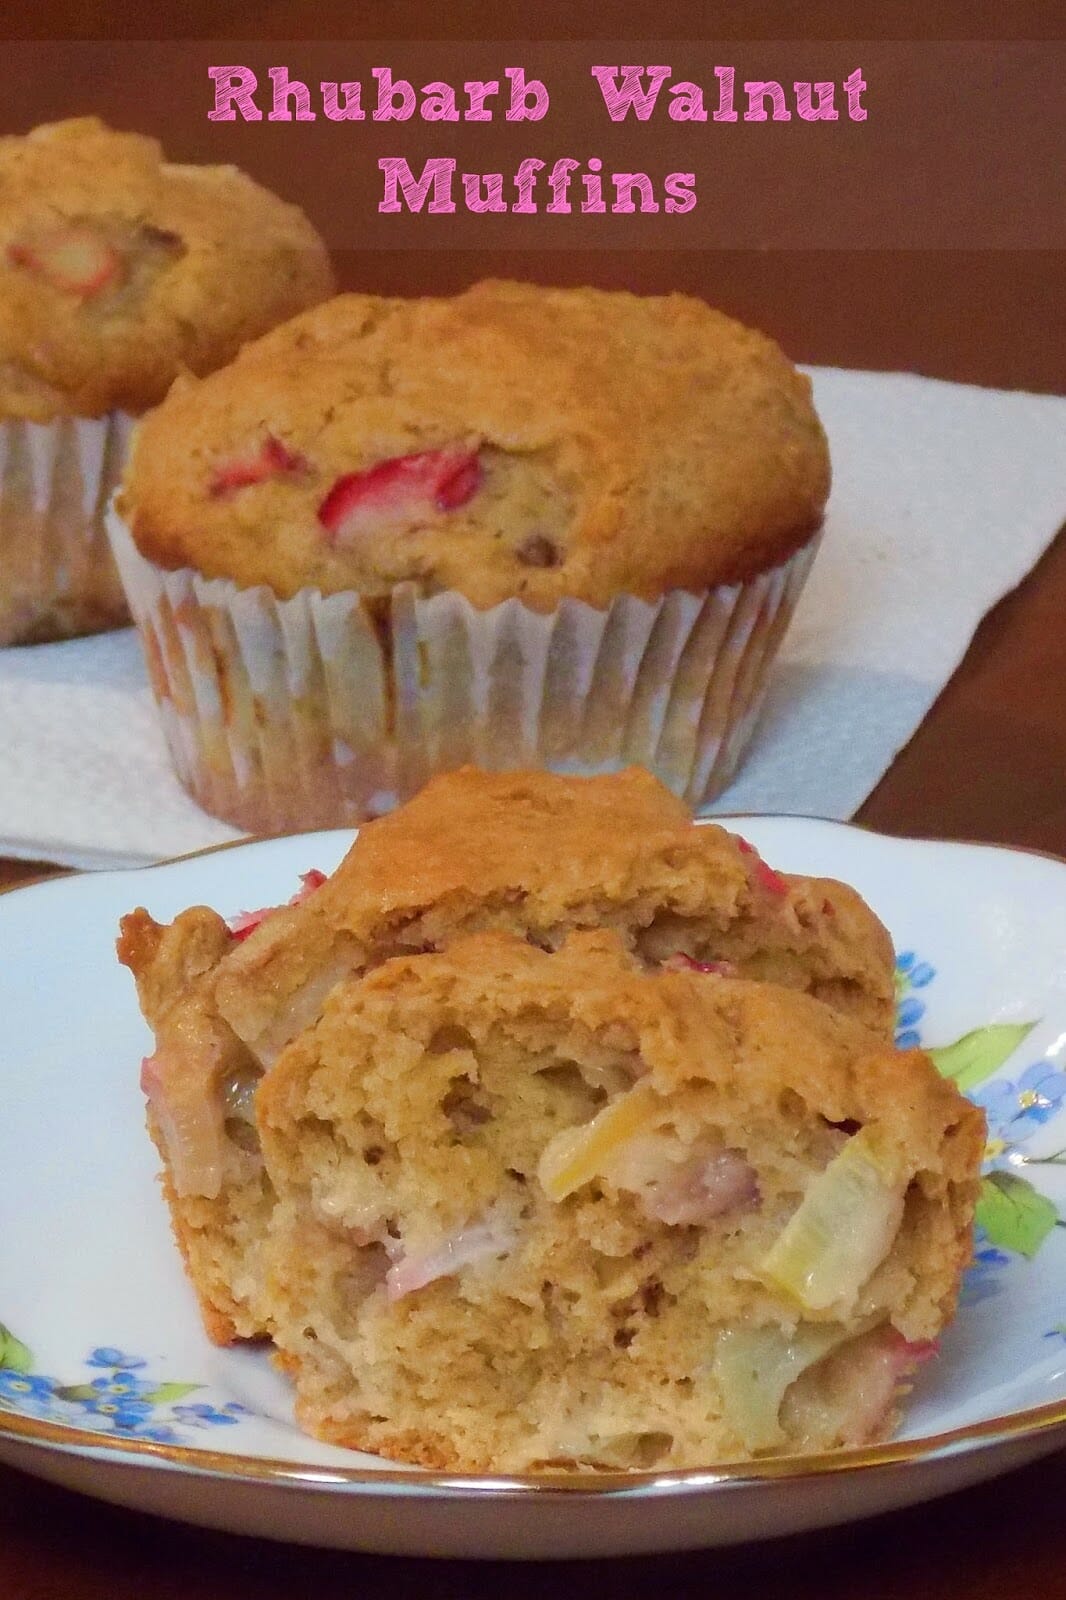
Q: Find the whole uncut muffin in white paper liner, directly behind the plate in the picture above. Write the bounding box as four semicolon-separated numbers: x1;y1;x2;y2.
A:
112;282;829;834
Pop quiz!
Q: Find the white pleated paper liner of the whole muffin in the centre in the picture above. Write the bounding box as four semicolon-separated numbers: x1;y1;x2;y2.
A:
109;512;818;834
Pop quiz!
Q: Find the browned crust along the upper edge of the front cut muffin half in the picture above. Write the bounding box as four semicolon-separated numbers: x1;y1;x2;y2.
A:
280;930;984;1176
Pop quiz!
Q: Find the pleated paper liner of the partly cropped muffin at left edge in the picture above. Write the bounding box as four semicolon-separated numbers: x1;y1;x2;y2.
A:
0;411;134;645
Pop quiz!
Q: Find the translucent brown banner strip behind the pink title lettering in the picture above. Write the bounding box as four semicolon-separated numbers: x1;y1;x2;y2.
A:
2;38;1066;252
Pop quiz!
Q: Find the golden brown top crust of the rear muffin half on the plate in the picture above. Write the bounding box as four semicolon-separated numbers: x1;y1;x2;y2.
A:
216;766;895;1050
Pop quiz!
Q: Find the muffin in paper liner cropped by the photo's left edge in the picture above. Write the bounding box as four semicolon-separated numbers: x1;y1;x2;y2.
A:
0;117;333;645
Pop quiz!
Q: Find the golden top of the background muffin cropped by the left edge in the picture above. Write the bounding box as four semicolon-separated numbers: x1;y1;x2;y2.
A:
0;117;333;422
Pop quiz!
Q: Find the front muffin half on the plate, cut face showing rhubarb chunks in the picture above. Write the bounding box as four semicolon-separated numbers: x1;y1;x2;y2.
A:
258;933;984;1472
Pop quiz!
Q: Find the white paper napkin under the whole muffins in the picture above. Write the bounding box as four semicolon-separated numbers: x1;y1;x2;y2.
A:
0;368;1066;867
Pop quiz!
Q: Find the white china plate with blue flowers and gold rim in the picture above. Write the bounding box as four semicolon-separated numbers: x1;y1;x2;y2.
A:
0;818;1066;1557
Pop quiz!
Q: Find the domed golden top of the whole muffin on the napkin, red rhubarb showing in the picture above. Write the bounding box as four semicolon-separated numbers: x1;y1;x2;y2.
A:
122;282;829;610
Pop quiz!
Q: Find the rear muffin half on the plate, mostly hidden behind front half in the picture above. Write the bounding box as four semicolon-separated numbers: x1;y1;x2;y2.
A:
118;768;893;1342
